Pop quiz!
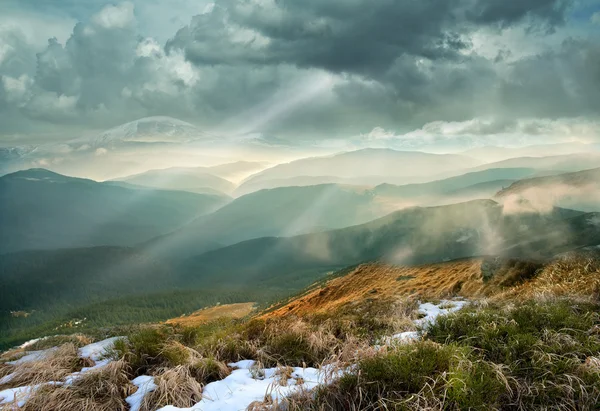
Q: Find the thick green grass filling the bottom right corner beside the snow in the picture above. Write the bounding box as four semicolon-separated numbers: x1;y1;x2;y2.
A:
280;300;600;411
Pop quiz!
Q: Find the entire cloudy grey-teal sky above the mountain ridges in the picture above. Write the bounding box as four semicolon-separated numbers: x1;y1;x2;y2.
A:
0;0;600;147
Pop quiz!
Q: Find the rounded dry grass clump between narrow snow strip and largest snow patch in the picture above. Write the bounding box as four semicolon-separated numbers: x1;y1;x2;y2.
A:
140;365;202;411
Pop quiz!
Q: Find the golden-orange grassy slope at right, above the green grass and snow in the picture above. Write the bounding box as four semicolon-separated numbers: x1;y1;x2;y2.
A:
260;251;600;318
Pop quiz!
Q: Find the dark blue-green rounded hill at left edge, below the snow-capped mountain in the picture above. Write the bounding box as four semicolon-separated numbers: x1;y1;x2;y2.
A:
0;169;224;253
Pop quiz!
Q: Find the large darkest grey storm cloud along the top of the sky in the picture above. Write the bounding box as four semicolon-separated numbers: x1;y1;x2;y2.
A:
167;0;570;75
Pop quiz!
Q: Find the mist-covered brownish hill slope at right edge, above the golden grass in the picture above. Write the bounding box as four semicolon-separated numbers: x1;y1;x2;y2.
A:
496;168;600;211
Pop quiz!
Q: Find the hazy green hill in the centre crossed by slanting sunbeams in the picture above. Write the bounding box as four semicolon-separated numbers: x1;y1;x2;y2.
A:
145;184;390;255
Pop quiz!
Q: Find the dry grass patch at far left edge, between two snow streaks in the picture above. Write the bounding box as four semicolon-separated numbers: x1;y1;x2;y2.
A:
0;343;93;389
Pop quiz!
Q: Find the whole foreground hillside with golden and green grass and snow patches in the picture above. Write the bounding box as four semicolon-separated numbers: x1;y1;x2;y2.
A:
0;252;600;411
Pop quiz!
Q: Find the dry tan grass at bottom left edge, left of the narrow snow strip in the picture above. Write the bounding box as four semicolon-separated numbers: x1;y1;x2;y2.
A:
22;361;135;411
